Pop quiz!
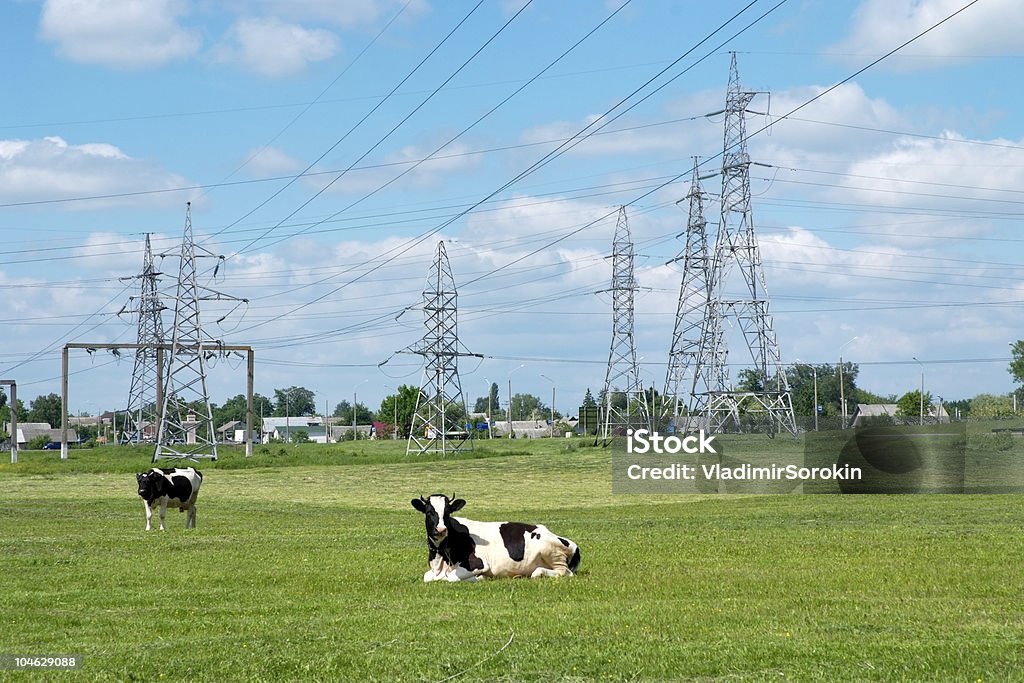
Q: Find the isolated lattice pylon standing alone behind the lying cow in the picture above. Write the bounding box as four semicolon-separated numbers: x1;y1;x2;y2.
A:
406;242;483;456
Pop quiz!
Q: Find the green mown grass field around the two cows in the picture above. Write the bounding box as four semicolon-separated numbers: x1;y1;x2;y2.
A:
0;437;1024;682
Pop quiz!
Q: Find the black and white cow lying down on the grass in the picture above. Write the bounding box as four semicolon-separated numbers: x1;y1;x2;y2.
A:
412;494;580;582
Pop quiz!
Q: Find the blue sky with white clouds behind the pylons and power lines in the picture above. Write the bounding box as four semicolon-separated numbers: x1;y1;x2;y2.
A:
0;0;1024;413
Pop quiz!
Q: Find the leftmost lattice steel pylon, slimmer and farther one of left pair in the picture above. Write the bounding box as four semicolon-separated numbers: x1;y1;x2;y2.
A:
120;232;164;443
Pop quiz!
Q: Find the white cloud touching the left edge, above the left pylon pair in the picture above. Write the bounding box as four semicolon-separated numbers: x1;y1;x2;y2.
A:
0;137;187;209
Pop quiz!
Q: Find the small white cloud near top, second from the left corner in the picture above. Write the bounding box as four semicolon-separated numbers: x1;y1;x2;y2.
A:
214;17;339;78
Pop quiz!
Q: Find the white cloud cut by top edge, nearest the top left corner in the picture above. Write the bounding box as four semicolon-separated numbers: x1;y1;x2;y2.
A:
39;0;202;70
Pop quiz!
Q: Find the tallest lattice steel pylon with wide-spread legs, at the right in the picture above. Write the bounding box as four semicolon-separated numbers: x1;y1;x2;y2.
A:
690;53;797;434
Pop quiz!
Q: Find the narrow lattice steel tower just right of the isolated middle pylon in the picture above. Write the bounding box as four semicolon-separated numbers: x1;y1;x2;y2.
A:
600;206;650;445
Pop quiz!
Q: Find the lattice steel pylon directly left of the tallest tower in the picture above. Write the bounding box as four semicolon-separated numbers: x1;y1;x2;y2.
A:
660;157;711;431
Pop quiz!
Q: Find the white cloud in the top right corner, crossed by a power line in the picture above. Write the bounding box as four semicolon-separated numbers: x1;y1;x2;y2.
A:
830;0;1024;70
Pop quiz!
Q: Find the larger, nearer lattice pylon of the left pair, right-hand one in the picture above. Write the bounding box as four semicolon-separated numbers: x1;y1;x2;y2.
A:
153;203;245;462
